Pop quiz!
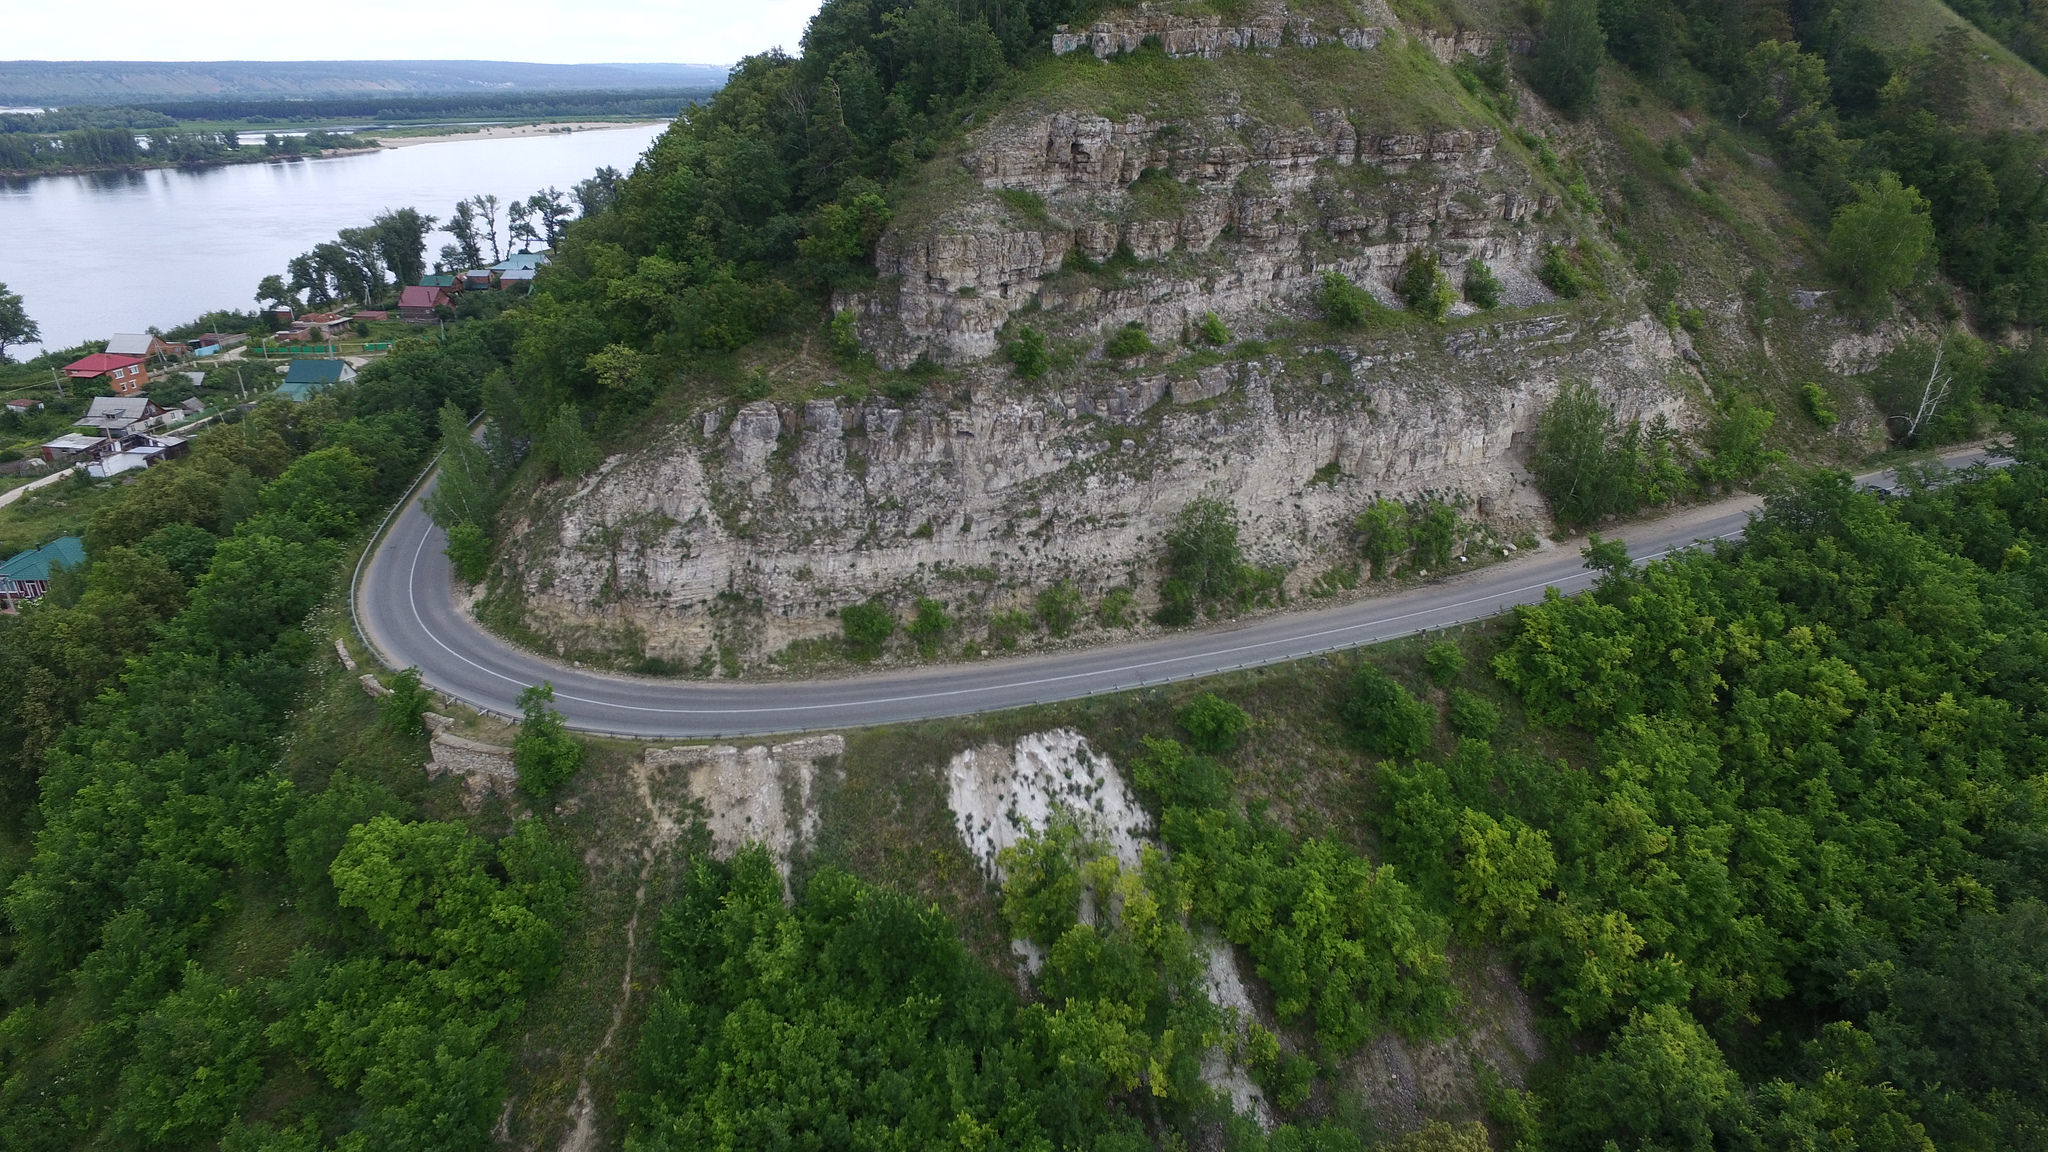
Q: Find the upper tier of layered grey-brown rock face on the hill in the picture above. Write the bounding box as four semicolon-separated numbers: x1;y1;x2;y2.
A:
840;97;1556;367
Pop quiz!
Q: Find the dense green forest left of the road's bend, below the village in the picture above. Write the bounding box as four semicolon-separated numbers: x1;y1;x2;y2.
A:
0;322;575;1150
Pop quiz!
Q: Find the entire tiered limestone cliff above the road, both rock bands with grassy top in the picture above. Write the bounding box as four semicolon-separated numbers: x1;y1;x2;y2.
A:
506;4;1728;672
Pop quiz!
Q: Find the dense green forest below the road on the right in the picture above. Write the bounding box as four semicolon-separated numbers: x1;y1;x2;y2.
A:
625;430;2048;1152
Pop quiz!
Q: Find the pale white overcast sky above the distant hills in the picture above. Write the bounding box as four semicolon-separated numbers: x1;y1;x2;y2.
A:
14;0;819;64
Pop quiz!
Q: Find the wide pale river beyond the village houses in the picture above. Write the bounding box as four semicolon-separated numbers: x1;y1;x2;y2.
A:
0;125;664;359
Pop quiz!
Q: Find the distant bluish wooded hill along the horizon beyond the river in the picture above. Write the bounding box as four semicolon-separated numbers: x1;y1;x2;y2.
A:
0;59;727;105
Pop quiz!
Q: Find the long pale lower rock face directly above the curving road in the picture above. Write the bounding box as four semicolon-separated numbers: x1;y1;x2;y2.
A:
503;314;1692;668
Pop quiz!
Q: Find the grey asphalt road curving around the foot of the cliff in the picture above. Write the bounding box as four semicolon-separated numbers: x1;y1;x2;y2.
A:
354;440;1991;738
